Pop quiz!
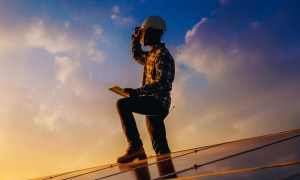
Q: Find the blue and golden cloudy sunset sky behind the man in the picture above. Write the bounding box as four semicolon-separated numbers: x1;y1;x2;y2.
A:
0;0;300;179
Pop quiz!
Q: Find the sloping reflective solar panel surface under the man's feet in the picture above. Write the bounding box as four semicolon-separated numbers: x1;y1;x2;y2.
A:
32;129;300;180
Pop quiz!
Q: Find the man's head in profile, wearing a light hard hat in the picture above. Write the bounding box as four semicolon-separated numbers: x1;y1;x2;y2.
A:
141;16;167;46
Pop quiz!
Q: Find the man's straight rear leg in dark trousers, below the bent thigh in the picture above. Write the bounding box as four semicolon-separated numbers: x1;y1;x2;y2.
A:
146;116;170;155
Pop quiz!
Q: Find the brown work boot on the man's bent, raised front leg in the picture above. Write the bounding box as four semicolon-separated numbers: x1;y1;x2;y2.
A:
117;146;147;164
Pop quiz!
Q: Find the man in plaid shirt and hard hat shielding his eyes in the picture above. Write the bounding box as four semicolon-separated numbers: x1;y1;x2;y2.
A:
117;16;175;163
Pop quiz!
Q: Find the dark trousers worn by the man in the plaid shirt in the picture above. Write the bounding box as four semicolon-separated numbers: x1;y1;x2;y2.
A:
117;96;170;154
